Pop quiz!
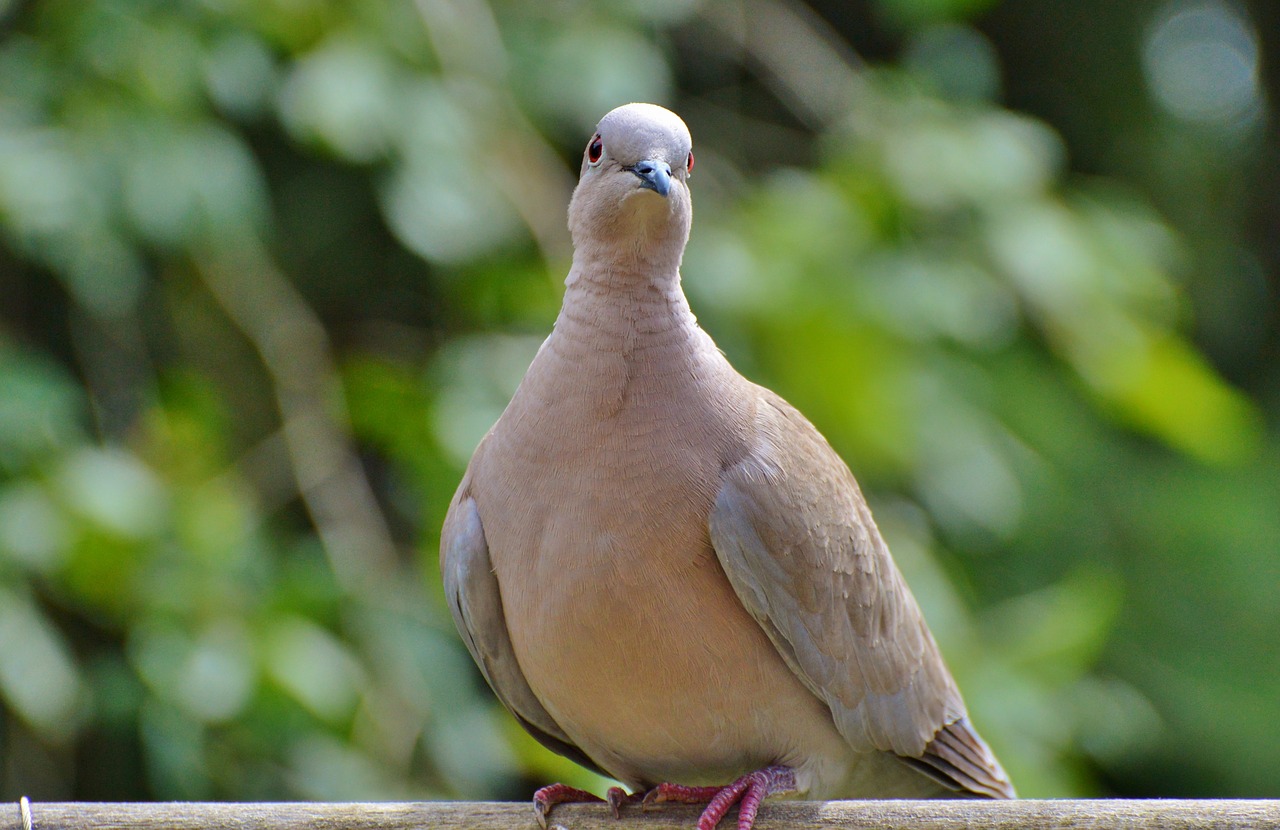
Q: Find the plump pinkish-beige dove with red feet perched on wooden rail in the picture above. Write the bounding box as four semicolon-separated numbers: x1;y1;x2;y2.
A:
440;104;1015;830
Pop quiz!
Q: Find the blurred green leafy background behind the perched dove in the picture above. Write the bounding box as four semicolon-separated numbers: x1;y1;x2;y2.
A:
0;0;1280;799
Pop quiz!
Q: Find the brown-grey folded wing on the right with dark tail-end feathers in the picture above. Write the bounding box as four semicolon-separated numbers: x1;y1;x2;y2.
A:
709;388;1012;798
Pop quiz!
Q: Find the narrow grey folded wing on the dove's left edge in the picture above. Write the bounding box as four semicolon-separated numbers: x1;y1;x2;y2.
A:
440;476;607;775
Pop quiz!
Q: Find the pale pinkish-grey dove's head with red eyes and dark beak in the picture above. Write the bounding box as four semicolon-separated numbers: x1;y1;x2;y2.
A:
568;104;694;263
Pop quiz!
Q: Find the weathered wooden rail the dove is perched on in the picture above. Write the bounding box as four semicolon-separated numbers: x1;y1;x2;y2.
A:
10;799;1280;830
